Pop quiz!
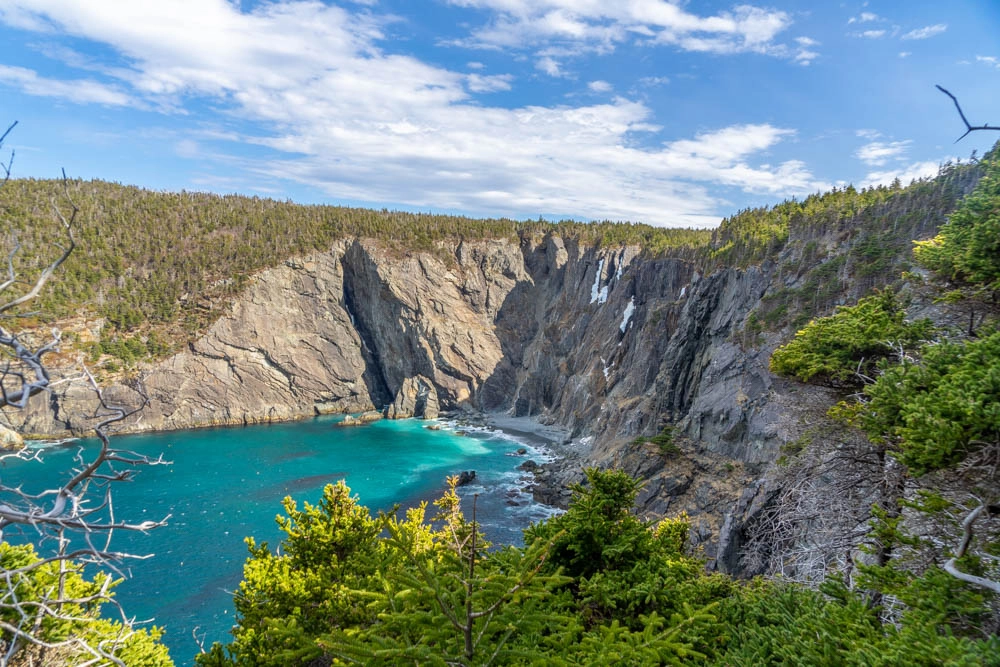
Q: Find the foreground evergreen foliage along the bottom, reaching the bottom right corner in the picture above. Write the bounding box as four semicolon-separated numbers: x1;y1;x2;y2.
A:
197;469;1000;667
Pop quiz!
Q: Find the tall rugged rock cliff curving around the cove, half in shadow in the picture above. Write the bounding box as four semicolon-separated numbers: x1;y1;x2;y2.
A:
7;164;972;570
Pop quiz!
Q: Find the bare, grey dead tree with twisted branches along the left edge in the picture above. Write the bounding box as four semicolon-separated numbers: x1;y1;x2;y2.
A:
0;123;166;667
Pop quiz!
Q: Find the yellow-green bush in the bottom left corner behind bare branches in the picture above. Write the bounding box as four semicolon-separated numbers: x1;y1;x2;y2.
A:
0;542;174;667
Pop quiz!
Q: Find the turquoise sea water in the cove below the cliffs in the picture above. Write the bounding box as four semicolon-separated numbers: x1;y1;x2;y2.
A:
0;417;552;665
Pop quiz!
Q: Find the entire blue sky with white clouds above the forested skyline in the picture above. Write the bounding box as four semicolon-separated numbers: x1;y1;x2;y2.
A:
0;0;1000;227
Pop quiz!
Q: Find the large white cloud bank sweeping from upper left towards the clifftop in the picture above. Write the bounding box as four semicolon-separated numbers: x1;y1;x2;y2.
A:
0;0;827;226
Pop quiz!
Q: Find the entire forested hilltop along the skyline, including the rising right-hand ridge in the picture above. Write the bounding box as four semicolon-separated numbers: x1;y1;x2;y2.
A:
0;158;978;370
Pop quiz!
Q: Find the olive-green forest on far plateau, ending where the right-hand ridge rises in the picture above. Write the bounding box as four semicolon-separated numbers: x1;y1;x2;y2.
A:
0;179;711;354
